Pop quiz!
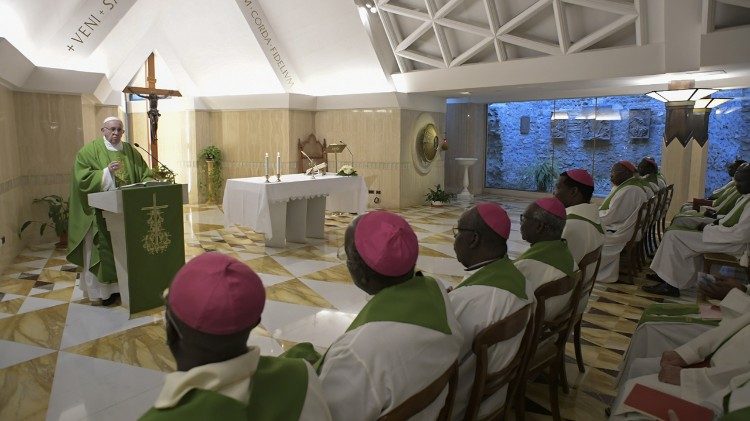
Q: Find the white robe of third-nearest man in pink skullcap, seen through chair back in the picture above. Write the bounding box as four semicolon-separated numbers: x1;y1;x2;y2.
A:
448;263;531;420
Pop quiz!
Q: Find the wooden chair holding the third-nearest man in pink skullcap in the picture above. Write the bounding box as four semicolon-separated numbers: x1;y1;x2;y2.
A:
464;304;534;421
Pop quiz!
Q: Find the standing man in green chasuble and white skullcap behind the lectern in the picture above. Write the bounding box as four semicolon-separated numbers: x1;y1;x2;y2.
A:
67;117;153;305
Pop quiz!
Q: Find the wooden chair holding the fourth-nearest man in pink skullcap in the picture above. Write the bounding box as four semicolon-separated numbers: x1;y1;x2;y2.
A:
515;270;581;421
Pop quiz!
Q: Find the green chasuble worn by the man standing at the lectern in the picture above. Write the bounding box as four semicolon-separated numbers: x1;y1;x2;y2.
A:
67;139;153;284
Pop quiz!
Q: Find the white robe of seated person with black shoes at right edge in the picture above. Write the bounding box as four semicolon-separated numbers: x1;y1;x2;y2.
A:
651;194;750;289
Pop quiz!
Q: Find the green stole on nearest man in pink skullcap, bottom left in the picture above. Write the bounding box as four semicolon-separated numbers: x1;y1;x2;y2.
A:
140;357;308;421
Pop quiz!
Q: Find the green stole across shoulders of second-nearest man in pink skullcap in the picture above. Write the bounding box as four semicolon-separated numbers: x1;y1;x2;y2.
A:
346;274;452;335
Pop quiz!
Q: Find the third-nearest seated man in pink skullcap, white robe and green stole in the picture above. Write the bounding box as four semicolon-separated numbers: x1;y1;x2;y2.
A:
448;203;531;420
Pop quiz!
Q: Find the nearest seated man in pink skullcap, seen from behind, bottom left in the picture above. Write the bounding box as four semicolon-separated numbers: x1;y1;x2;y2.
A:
141;253;331;421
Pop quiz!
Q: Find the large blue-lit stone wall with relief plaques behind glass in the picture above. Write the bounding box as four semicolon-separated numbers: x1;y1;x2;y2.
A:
485;95;665;195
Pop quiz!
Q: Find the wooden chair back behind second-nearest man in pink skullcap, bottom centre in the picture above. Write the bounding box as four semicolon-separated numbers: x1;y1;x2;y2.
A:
378;361;458;421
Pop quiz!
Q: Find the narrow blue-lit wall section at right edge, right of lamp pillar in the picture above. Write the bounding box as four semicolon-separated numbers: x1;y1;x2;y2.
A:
706;88;750;195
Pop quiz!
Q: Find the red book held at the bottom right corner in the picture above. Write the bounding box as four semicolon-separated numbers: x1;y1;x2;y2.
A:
625;384;714;421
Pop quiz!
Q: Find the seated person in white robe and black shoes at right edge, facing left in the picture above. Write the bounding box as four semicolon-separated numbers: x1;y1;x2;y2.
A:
642;164;750;297
